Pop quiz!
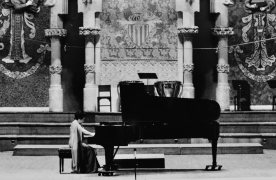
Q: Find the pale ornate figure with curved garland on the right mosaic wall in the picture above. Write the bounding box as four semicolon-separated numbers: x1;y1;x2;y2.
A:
229;0;276;82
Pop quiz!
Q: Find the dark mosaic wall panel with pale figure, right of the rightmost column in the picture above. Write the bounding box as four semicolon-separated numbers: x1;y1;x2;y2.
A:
229;0;276;105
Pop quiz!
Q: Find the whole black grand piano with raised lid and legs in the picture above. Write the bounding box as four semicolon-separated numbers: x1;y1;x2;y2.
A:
87;81;222;175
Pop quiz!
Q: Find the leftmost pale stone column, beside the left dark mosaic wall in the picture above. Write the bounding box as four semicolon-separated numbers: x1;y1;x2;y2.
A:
45;0;67;112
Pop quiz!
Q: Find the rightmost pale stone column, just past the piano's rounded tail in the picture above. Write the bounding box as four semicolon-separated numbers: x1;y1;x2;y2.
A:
210;0;234;110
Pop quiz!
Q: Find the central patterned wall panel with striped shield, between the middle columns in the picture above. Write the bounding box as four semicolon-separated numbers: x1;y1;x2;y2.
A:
100;0;177;84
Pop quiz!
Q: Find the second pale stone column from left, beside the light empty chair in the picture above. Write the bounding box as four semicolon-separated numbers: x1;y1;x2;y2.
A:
78;0;102;112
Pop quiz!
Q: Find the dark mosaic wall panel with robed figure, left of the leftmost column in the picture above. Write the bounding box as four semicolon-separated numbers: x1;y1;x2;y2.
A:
0;1;50;107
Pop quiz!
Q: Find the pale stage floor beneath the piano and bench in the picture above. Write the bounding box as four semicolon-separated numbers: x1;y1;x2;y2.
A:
0;150;276;180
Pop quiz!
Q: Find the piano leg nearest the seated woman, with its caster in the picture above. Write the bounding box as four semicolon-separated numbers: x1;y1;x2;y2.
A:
98;145;114;176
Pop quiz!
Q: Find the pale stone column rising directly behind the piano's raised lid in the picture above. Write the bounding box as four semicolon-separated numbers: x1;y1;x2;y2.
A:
176;0;199;98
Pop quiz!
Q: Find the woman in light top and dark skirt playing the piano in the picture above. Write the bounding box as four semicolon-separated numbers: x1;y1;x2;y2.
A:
69;112;99;173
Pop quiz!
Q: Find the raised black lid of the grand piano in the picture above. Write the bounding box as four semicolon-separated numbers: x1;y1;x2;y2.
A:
119;80;220;124
